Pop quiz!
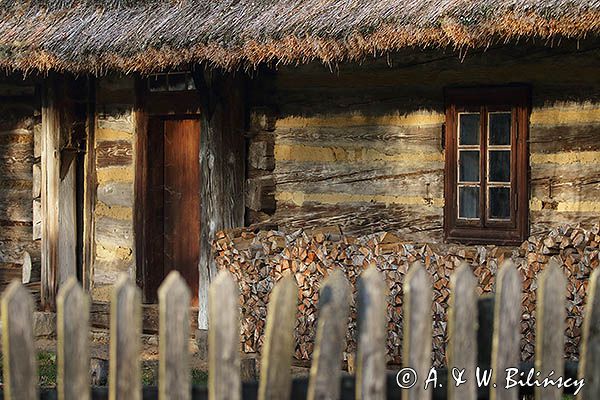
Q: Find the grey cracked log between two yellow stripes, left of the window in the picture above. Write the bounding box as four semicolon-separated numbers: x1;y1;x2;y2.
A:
273;160;444;199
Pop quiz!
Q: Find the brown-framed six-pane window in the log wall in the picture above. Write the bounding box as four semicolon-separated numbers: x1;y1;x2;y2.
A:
444;86;529;244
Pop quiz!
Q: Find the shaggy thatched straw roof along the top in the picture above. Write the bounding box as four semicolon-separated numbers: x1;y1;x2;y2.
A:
0;0;600;73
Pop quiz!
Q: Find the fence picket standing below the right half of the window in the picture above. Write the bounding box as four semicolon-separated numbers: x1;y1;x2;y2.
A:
490;261;522;400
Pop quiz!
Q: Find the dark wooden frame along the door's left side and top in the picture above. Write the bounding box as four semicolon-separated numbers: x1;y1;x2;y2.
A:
133;77;202;303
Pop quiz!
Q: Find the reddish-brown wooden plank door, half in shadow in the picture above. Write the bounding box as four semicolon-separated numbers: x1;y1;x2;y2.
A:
144;117;201;305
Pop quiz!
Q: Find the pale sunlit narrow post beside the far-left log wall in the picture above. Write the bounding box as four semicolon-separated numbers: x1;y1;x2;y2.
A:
41;75;60;310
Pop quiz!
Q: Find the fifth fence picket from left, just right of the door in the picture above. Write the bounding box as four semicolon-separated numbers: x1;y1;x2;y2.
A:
208;271;242;400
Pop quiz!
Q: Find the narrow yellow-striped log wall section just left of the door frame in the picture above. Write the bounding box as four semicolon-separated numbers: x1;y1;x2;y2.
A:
92;76;135;301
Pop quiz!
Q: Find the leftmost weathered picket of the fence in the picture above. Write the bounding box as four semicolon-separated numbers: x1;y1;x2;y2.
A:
1;280;38;400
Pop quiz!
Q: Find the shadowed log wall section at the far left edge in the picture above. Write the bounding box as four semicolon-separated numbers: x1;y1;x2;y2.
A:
0;75;41;286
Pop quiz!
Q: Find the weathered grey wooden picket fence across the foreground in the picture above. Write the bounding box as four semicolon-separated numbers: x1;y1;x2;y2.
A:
2;260;600;400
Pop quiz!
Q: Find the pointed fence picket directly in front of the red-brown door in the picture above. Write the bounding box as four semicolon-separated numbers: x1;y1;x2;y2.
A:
158;270;192;400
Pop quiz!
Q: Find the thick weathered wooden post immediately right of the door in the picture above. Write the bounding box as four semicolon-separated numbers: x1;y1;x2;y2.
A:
195;70;246;330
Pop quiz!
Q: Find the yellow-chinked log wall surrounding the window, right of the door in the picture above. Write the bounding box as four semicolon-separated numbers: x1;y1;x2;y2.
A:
246;43;600;242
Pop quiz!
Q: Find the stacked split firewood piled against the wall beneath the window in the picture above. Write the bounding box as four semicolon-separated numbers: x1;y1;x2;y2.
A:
213;226;600;365
